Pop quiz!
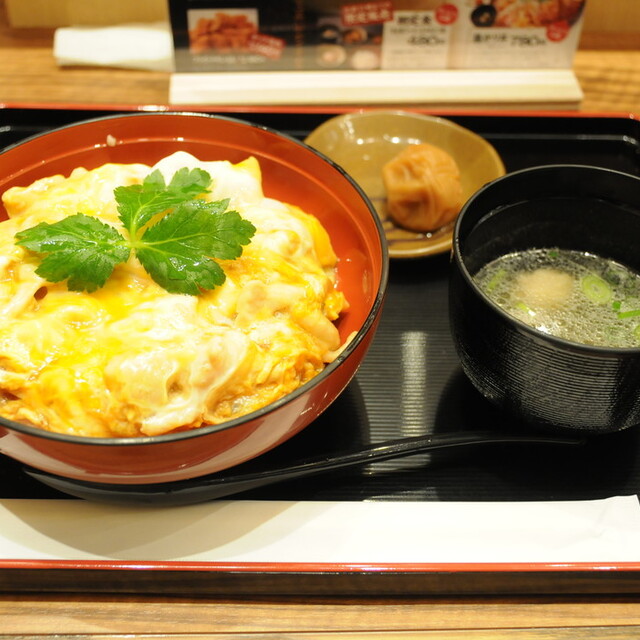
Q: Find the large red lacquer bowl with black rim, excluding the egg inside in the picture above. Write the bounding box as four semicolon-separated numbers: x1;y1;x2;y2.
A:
0;113;388;485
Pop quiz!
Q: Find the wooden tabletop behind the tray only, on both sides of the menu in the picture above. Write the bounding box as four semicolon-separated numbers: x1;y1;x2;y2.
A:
0;0;640;113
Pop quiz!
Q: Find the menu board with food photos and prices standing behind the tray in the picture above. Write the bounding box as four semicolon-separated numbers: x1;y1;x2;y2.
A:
169;0;586;72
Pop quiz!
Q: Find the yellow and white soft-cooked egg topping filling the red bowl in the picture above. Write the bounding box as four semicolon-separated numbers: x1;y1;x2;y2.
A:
0;152;348;437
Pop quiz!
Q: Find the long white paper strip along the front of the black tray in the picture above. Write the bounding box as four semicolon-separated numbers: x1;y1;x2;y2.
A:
0;496;640;564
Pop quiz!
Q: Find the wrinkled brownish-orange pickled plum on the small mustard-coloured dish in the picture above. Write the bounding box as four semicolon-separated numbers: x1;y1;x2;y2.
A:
382;144;463;231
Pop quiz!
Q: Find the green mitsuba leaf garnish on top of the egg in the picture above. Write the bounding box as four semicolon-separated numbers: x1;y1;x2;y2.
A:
16;168;256;295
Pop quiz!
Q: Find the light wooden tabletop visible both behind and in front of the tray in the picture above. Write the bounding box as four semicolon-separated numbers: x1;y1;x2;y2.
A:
0;2;640;640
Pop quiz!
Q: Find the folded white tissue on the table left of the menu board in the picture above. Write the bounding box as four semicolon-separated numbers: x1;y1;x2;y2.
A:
53;22;174;71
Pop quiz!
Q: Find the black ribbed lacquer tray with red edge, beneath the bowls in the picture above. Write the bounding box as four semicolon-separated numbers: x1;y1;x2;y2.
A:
0;108;640;593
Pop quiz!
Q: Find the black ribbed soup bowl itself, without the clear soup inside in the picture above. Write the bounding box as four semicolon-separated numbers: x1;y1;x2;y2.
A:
449;165;640;434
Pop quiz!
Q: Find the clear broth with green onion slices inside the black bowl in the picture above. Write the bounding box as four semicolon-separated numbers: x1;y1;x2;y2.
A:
474;249;640;347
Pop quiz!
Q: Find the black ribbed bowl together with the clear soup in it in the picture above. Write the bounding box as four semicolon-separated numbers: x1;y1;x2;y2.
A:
449;165;640;433
